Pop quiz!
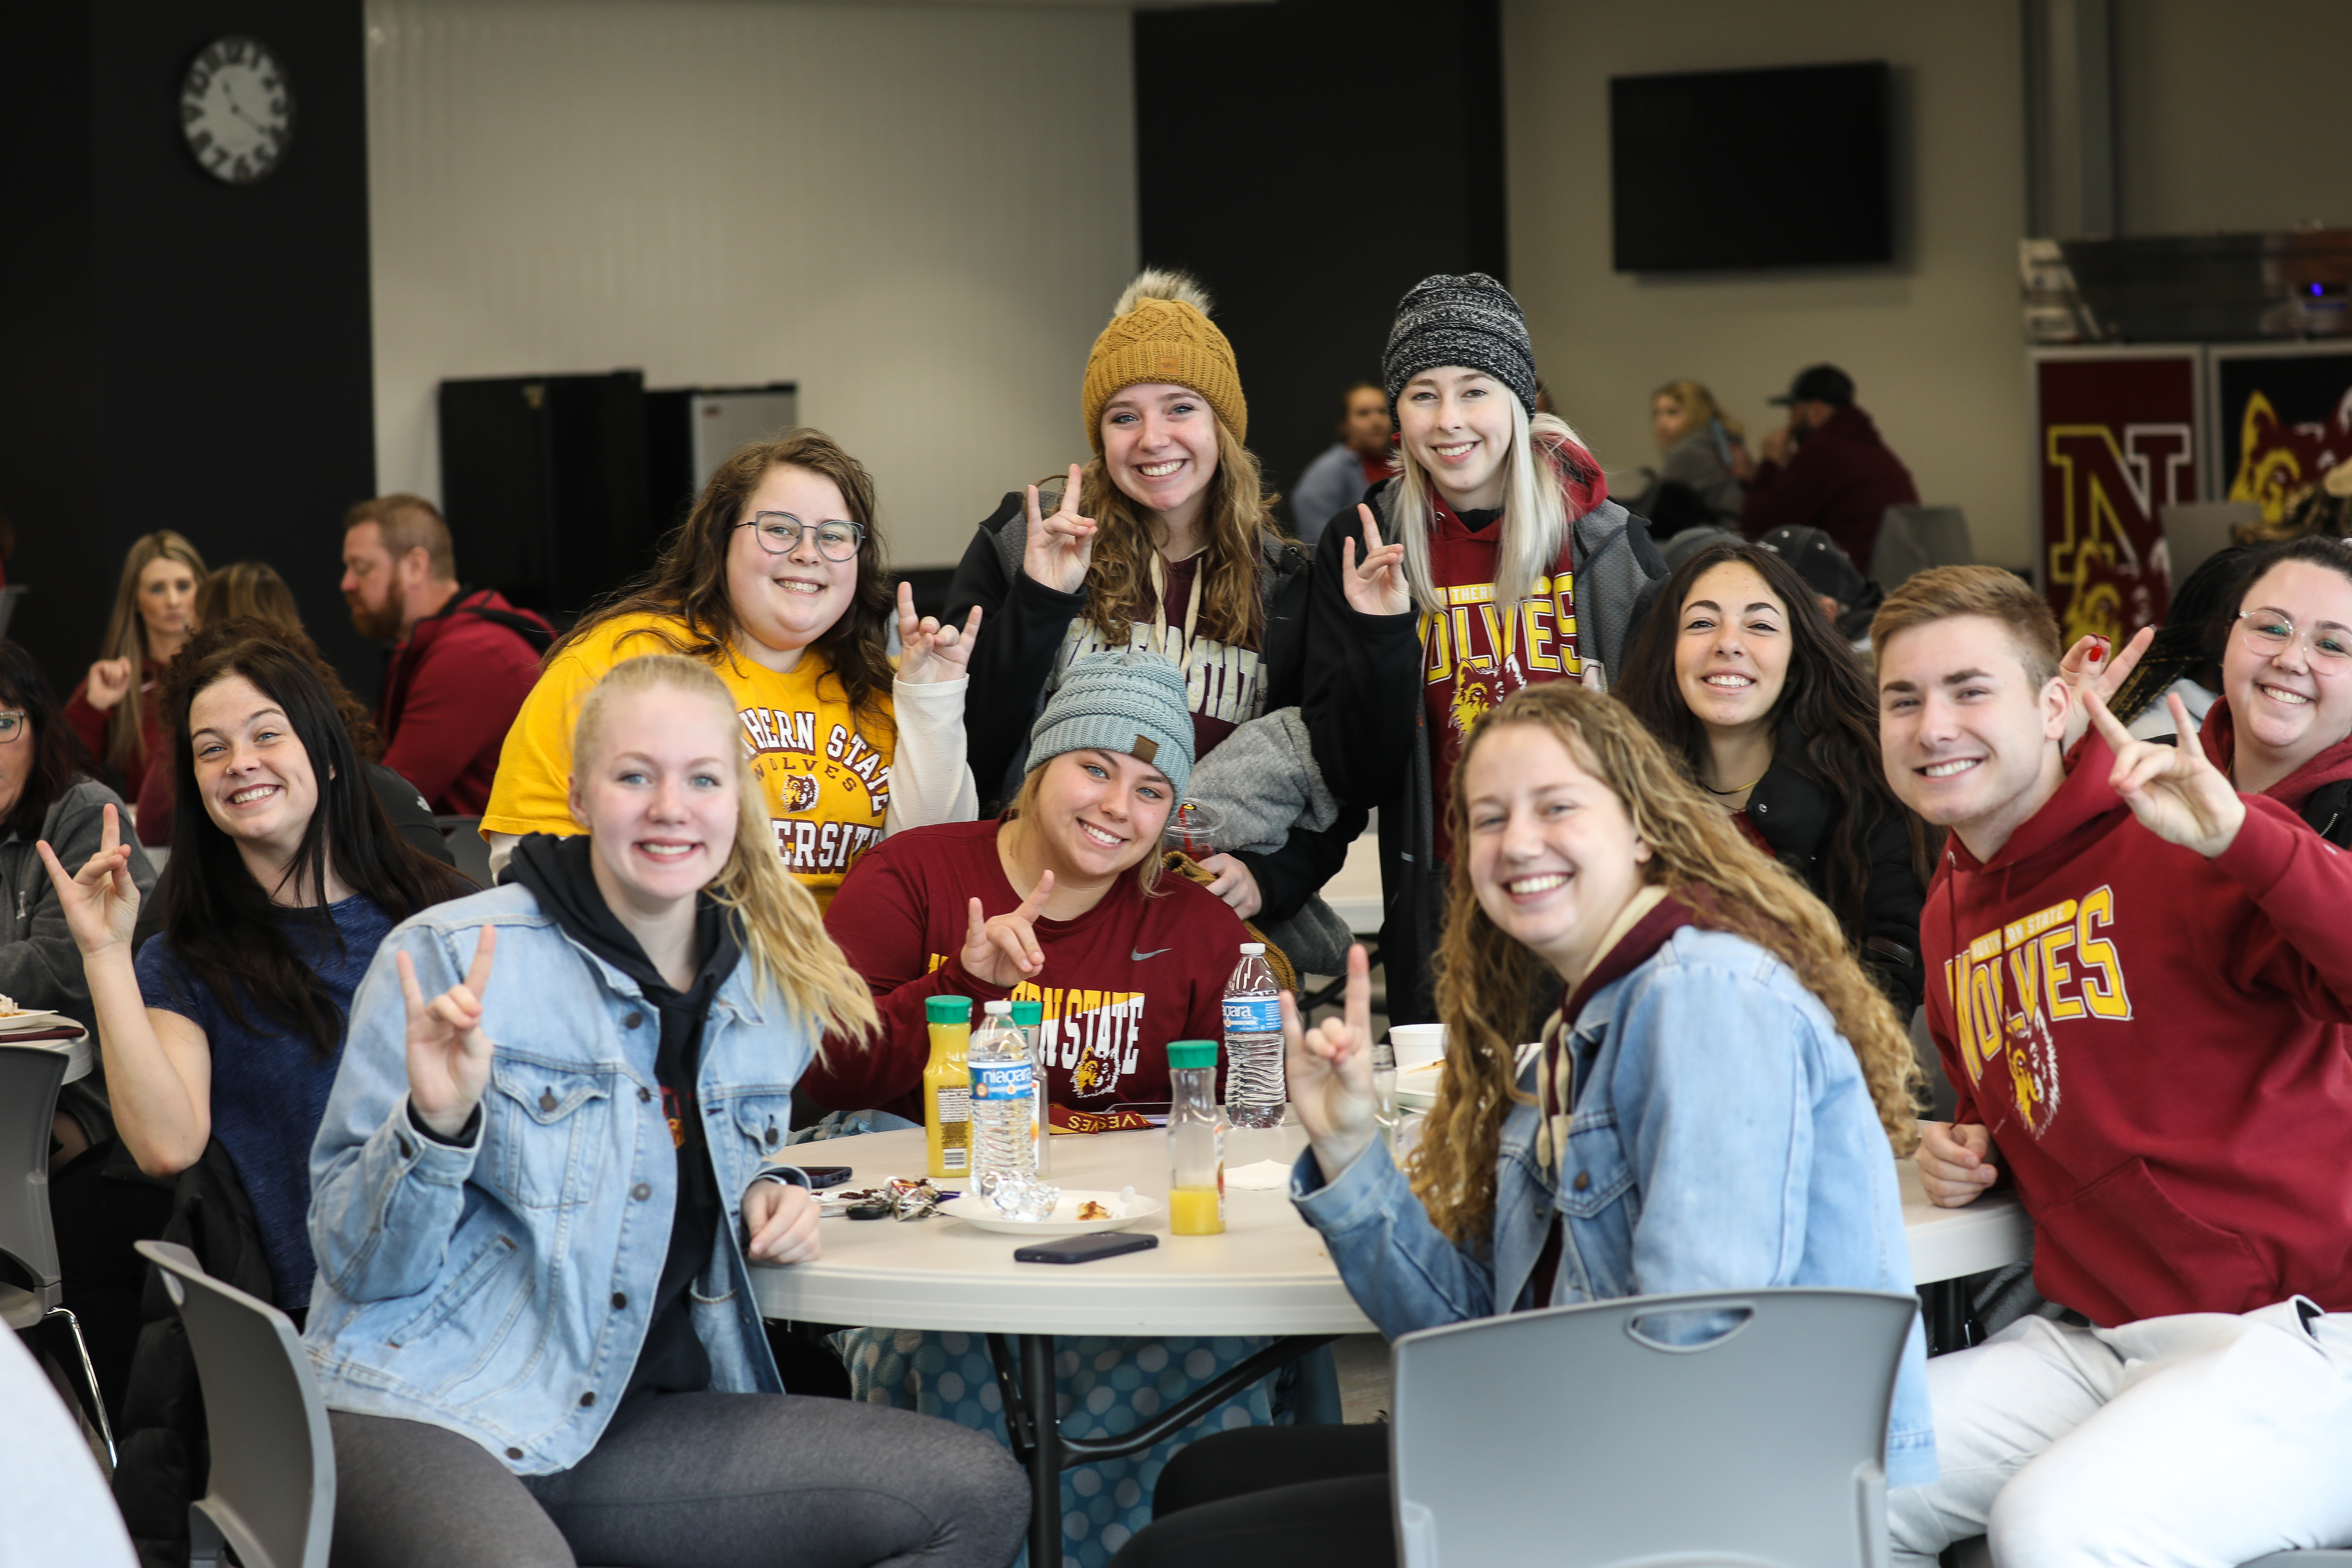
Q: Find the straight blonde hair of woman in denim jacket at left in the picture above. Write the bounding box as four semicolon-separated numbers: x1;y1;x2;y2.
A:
572;653;880;1056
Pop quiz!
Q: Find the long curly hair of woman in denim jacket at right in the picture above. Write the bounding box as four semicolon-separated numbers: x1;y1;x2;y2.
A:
1411;682;1919;1241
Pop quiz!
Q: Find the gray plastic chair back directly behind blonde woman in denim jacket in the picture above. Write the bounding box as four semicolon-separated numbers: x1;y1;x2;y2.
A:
139;1241;334;1568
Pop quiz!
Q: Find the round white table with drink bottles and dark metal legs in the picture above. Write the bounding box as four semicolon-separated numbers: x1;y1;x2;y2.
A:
752;1126;2032;1568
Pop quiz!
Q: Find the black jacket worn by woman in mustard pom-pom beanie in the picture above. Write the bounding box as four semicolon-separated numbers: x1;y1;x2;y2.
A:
943;491;1366;922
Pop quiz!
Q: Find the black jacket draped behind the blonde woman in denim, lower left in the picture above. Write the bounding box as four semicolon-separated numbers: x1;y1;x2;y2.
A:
115;1138;275;1568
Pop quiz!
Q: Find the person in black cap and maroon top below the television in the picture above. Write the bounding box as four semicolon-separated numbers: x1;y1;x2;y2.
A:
1741;364;1919;571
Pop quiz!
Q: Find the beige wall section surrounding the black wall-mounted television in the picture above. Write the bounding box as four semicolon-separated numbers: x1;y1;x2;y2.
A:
1503;0;2035;564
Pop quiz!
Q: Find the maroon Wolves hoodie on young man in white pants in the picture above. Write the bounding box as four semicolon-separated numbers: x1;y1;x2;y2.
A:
1919;734;2352;1326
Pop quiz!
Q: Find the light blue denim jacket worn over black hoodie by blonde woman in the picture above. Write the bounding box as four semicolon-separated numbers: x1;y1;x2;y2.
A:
303;886;816;1474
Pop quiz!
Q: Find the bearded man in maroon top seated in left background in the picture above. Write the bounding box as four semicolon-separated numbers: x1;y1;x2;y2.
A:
343;496;555;816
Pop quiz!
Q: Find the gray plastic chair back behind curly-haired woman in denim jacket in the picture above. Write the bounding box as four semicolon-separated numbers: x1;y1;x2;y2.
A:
1390;1290;1919;1568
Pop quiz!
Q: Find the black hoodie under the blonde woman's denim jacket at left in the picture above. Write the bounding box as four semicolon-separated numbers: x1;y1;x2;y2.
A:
506;834;743;1410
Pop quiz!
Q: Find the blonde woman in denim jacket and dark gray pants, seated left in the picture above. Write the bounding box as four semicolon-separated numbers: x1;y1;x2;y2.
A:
306;656;1028;1568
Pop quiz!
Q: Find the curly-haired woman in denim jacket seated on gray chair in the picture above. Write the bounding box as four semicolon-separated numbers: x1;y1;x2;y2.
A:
1120;682;1936;1568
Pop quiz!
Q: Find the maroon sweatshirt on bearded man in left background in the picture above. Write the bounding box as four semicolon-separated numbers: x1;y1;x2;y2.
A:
376;588;555;816
